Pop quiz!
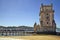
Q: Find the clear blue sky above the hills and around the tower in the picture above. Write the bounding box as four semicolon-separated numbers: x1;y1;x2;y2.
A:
0;0;60;27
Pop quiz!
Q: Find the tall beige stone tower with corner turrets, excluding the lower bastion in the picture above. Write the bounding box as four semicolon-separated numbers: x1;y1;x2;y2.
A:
39;4;56;32
